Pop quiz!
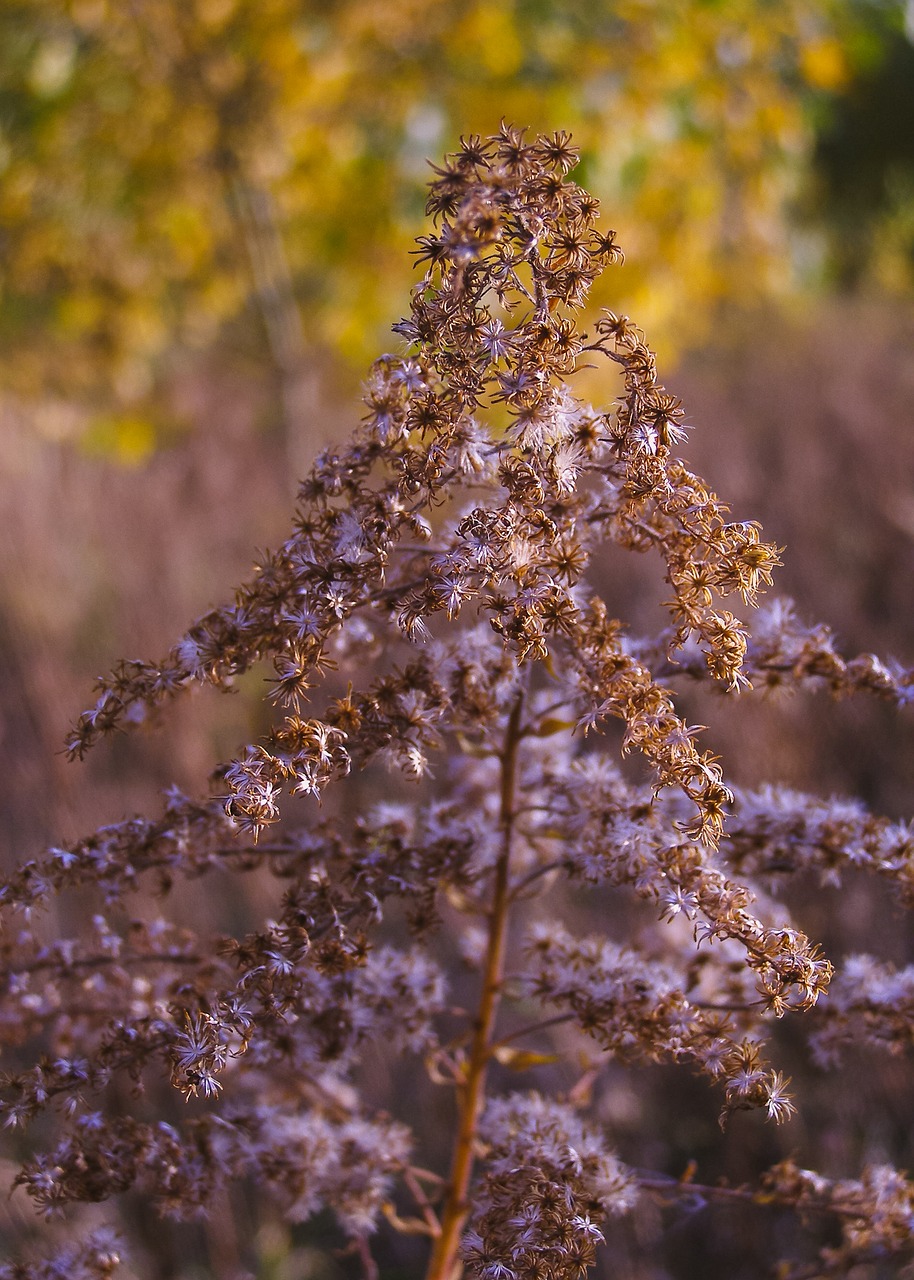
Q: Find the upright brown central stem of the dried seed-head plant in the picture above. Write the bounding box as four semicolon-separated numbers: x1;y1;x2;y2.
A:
426;694;524;1280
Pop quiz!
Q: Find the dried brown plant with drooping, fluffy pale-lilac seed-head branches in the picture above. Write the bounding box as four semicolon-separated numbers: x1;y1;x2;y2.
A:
0;127;914;1280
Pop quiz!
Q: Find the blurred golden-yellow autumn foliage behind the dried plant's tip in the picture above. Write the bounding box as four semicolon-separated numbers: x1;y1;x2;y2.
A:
0;0;914;440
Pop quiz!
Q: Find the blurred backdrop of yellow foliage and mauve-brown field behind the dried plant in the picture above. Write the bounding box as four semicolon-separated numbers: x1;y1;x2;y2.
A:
0;0;914;1276
